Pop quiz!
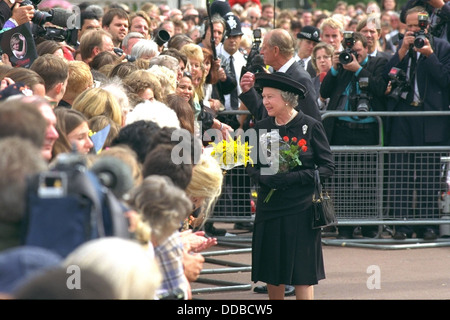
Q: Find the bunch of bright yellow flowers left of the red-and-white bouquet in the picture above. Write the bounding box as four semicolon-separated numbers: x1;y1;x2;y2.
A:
210;137;253;170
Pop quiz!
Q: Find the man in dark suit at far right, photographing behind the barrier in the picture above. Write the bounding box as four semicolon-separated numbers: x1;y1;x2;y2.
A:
385;7;450;240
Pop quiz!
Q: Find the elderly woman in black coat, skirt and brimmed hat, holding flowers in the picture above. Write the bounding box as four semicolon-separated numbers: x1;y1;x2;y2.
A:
247;72;335;299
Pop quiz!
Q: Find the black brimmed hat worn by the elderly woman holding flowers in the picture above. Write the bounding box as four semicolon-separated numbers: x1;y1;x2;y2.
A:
255;72;307;99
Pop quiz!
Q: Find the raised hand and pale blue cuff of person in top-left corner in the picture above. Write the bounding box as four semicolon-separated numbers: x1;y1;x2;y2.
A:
0;0;34;29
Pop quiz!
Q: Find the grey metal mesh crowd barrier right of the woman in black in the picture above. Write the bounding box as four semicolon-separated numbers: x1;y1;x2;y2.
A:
322;111;450;249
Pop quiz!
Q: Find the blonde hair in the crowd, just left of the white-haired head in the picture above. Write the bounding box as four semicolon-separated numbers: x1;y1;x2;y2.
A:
72;88;123;127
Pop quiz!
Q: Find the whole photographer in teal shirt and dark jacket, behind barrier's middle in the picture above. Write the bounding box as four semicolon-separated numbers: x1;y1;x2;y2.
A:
320;32;387;239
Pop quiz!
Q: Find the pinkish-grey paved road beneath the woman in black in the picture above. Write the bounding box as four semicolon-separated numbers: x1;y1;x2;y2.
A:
193;225;450;300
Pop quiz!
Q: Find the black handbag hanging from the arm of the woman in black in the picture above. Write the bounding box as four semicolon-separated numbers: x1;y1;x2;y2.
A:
312;170;337;229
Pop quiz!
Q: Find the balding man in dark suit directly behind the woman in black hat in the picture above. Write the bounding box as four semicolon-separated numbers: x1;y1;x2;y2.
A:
239;29;321;121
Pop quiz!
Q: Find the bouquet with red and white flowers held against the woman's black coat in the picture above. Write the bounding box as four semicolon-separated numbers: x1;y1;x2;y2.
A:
260;131;308;203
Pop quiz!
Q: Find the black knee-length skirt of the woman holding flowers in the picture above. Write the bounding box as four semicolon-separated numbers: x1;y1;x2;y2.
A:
252;208;325;285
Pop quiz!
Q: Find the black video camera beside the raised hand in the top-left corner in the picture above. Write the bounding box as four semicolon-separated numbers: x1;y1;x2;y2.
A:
21;0;78;46
